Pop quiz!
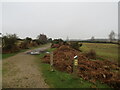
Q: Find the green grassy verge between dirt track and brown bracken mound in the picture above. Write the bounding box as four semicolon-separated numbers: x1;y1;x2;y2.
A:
36;49;110;88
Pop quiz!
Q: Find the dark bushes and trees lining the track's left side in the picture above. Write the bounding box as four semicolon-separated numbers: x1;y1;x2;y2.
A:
2;34;51;53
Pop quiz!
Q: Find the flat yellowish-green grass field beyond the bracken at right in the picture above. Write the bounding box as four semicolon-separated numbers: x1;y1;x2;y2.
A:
80;43;118;61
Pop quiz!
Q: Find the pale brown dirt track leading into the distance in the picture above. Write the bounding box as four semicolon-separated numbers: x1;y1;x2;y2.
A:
2;47;49;88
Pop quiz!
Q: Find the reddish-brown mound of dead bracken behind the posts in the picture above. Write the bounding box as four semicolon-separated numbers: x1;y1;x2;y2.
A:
43;45;120;88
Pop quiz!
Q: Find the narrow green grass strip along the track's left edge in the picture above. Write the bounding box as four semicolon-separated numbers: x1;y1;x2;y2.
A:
0;44;49;59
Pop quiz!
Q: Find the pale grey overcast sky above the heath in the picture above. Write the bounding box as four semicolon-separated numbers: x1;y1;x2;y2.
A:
0;2;118;39
